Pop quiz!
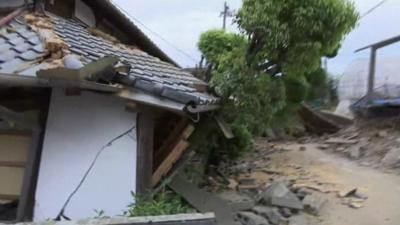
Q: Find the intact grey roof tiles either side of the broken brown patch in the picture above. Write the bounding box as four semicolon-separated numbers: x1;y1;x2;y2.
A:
0;12;218;104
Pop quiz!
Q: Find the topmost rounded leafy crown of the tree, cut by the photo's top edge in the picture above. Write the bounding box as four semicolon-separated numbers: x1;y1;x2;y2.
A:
236;0;359;74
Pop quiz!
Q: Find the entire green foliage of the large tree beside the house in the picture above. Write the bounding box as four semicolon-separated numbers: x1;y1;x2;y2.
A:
194;0;359;158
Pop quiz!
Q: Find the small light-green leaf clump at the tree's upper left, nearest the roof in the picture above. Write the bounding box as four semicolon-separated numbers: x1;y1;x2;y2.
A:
198;30;246;66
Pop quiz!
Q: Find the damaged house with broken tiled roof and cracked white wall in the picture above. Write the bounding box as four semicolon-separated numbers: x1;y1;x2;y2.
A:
0;0;218;221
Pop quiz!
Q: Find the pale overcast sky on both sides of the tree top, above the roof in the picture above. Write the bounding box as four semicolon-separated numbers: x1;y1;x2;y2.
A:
112;0;400;75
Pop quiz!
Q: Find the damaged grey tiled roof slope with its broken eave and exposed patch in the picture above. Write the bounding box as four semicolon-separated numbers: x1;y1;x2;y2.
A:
0;13;218;112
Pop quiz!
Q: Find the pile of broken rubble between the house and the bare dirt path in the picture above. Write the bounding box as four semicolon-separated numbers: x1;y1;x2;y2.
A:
195;137;376;225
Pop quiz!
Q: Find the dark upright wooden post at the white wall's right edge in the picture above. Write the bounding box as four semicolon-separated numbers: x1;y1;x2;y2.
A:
136;109;154;195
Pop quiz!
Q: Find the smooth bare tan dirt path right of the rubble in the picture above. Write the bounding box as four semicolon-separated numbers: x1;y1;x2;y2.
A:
271;144;400;225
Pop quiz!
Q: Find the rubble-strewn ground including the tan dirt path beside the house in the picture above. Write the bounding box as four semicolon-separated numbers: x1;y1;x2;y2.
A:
209;123;400;225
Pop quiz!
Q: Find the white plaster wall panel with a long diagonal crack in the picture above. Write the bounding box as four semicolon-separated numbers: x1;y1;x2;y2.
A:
34;89;136;221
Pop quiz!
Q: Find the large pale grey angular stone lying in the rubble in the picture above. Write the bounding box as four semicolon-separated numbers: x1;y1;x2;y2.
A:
261;182;303;209
